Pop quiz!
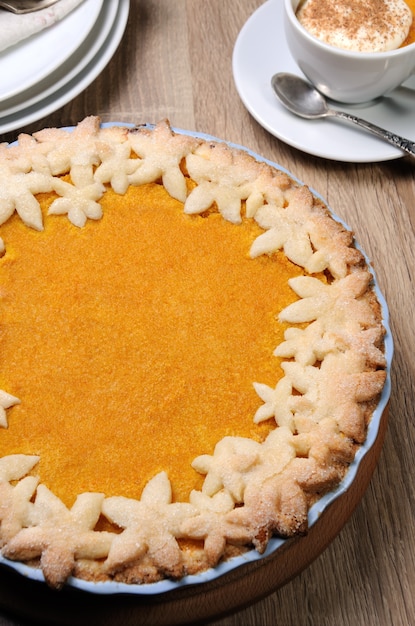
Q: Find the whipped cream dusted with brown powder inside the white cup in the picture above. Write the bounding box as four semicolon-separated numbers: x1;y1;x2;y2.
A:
297;0;413;52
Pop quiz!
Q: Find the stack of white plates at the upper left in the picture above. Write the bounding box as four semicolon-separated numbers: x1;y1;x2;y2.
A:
0;0;130;133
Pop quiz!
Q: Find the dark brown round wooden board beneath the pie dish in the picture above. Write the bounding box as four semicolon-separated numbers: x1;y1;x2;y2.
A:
0;409;388;626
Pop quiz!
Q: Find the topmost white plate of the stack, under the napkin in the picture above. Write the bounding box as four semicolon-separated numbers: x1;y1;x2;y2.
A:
0;0;103;101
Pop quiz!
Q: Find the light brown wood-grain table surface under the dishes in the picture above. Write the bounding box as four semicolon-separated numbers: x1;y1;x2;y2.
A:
0;0;415;626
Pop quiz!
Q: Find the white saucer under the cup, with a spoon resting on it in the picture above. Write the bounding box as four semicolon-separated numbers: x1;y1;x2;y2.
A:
232;0;415;163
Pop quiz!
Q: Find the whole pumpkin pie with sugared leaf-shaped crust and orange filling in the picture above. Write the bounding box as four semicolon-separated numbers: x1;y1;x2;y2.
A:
0;117;386;588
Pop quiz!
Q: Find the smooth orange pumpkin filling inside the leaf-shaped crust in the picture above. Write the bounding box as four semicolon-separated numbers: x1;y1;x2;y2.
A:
0;183;303;507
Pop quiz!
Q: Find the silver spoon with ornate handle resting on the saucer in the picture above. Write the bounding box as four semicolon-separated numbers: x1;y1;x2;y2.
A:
271;72;415;156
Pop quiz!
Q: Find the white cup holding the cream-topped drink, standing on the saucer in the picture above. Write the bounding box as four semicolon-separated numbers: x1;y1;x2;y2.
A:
283;0;415;104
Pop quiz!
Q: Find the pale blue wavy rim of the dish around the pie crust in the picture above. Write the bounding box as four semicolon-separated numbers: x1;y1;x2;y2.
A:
0;122;394;596
